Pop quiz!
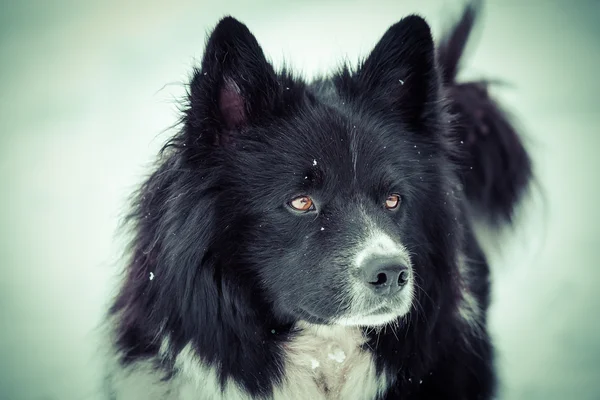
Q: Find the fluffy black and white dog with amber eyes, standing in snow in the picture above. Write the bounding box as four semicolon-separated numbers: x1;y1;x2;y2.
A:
105;4;532;400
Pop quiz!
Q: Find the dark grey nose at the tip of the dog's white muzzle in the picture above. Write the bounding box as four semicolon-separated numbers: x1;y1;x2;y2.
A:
363;257;409;296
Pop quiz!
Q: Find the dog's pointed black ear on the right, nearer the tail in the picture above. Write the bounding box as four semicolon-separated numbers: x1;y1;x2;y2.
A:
357;15;439;123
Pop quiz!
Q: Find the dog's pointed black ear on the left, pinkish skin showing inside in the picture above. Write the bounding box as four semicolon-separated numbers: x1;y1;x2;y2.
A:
186;17;279;145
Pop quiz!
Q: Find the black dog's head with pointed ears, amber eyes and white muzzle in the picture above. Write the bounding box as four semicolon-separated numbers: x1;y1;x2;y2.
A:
124;16;462;332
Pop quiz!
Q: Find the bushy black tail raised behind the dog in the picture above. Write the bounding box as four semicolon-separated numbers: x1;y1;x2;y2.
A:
437;1;532;223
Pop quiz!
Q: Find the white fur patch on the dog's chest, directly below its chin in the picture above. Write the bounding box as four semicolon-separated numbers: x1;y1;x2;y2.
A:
274;325;386;400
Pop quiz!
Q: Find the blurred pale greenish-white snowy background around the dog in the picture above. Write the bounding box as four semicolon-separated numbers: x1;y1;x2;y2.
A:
0;0;600;400
